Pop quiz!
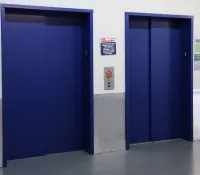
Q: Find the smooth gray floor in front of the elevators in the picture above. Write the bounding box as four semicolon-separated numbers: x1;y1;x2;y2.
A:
0;140;200;175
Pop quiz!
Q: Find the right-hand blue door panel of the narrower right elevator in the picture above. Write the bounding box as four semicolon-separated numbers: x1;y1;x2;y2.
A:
151;18;181;141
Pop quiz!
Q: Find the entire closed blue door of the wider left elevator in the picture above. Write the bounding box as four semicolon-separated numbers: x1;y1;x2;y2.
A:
3;15;83;160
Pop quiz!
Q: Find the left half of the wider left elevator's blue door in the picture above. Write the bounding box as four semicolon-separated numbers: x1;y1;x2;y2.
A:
2;14;48;159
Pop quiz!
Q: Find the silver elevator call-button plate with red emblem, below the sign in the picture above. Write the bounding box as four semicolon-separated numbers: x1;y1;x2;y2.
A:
104;67;115;90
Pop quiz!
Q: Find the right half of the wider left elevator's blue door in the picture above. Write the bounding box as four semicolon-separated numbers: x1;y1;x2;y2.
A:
44;17;83;153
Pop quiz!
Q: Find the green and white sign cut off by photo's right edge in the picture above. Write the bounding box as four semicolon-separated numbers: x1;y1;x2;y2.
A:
194;39;200;70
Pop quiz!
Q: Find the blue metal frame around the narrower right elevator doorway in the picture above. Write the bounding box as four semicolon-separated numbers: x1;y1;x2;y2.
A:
125;12;193;150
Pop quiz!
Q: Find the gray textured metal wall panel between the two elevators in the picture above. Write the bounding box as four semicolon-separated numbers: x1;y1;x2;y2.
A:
94;93;125;154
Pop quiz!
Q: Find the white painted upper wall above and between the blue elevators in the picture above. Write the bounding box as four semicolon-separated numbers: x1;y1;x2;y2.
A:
0;0;200;166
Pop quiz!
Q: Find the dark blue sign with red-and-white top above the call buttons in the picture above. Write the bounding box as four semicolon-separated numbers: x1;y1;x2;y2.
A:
100;38;116;55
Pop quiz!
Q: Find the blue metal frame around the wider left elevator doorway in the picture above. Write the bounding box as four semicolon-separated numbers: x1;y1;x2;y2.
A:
0;4;94;167
